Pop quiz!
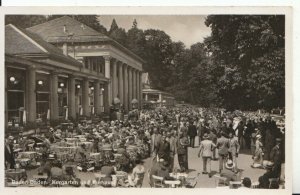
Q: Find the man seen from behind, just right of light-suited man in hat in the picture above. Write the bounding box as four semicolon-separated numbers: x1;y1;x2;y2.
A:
217;132;230;173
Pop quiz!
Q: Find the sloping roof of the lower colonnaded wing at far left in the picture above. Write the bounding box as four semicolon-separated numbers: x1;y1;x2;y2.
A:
5;24;82;66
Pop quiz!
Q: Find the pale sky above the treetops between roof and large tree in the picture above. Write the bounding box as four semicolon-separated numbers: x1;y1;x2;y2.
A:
99;15;211;48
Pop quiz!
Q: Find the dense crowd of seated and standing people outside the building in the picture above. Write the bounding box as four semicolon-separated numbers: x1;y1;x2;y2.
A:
5;107;285;188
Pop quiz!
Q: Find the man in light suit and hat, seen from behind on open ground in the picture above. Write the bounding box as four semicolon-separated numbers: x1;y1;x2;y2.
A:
198;133;216;175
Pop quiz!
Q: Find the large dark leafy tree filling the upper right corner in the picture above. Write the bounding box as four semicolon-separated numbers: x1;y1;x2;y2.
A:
205;15;285;109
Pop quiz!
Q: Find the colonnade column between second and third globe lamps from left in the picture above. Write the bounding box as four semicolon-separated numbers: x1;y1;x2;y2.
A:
50;72;59;120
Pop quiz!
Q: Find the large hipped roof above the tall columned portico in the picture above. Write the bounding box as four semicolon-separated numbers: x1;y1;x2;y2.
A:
27;16;144;63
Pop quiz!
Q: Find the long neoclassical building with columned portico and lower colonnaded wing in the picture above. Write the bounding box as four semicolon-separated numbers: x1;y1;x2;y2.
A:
5;16;143;124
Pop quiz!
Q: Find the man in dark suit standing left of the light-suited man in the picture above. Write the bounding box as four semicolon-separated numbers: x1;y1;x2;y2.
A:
177;132;190;172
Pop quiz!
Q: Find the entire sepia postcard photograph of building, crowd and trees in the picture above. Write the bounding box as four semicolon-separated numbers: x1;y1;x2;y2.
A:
2;6;290;191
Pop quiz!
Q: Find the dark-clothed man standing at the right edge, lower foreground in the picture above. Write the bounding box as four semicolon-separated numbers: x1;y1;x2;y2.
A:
270;138;282;177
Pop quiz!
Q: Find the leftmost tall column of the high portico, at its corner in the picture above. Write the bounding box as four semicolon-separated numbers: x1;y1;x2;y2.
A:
104;56;112;112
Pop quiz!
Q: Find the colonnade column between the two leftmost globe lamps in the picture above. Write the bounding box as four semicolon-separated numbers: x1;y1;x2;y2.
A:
26;67;36;123
